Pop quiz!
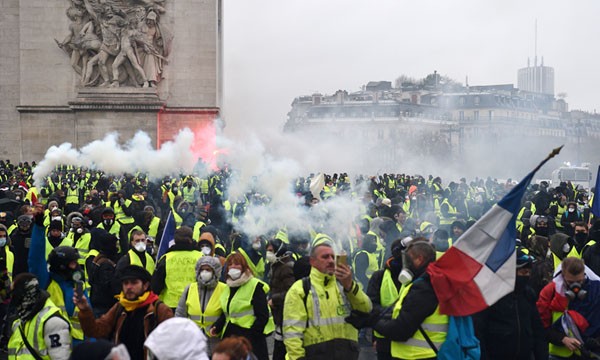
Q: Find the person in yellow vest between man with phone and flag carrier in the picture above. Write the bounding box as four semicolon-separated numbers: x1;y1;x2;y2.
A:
367;239;404;360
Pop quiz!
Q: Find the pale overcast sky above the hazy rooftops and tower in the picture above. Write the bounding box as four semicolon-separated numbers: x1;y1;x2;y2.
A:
223;0;600;138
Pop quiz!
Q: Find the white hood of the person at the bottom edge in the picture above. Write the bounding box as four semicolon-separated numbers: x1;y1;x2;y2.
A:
144;317;208;360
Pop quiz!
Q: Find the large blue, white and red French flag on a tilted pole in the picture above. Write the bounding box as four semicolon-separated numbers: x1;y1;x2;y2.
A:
427;146;562;316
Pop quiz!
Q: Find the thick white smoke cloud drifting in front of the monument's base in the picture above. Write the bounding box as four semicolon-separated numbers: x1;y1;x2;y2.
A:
33;128;196;186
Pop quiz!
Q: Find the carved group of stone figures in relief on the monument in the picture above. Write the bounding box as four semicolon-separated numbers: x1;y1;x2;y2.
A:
55;0;172;87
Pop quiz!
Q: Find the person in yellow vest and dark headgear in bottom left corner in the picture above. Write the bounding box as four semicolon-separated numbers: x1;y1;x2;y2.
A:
8;273;72;360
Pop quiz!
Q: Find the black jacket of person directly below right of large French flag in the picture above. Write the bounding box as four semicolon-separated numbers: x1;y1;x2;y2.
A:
474;286;548;360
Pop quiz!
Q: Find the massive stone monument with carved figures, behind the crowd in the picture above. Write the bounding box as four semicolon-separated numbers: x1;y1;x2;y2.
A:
0;0;222;161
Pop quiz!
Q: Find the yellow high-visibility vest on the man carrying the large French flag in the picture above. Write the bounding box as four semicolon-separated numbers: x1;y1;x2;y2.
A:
391;283;448;359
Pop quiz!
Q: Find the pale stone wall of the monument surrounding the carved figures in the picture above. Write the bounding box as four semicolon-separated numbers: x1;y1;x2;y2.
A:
0;0;221;162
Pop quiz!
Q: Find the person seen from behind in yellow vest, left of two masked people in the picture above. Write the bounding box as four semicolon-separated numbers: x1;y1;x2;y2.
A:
152;226;202;309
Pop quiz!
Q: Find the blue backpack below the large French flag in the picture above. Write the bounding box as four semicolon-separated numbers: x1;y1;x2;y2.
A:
419;316;481;360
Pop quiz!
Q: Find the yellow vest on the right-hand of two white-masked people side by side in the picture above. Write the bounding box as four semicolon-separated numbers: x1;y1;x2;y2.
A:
220;277;275;335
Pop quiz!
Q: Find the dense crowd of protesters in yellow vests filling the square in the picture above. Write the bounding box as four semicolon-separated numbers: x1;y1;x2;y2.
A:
0;161;600;360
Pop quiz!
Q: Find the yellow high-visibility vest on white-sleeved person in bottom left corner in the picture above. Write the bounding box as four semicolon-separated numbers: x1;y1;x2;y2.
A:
8;299;65;360
